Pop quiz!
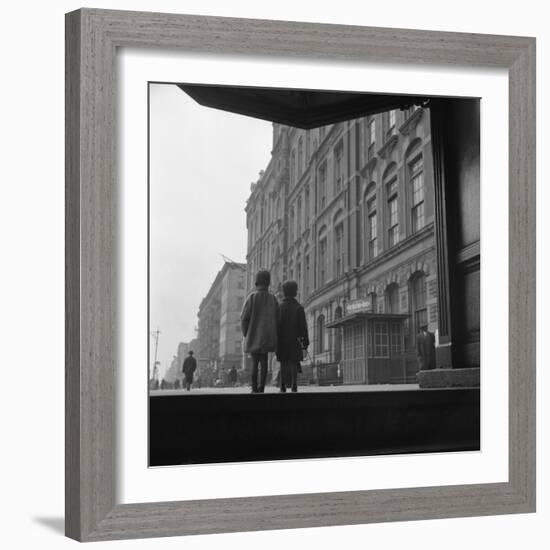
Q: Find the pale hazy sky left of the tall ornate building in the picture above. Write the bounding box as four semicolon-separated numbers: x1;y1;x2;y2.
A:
150;84;272;373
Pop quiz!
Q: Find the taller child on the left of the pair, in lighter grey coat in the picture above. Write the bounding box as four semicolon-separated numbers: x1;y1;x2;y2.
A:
241;270;279;393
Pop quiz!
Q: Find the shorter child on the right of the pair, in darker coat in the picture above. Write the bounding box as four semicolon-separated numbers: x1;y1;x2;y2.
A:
277;281;309;392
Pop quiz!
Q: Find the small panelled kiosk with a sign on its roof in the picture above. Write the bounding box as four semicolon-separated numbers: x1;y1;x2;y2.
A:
326;300;409;384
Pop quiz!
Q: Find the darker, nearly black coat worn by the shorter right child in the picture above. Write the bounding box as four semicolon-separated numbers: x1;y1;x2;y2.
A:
277;298;309;361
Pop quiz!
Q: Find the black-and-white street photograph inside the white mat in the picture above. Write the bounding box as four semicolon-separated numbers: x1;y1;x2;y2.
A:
149;82;481;467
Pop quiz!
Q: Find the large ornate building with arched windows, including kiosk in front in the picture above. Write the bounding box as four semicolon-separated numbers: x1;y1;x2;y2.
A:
246;107;438;384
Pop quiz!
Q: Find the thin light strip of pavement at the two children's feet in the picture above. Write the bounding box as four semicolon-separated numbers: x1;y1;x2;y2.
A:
150;384;420;397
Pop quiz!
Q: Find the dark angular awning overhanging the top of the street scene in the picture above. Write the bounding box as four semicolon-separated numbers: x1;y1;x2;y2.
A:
178;84;430;130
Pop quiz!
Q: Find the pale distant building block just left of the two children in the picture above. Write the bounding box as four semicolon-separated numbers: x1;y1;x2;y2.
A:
197;262;246;373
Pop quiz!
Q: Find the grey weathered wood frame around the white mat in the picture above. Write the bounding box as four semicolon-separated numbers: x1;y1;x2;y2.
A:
66;9;535;541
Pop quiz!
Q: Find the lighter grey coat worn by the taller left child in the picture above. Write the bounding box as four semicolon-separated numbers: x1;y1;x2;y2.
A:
241;287;279;353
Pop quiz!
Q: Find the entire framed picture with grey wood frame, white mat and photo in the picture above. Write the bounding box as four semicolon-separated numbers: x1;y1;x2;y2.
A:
66;9;535;541
